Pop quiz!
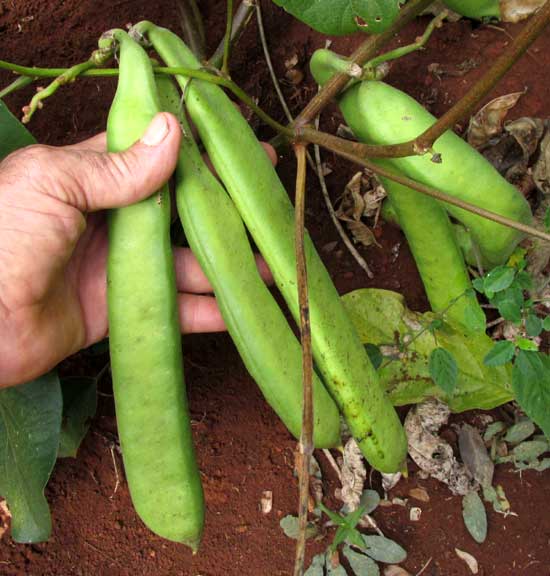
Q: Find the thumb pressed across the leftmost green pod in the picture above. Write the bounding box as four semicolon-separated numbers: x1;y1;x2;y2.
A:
62;112;181;212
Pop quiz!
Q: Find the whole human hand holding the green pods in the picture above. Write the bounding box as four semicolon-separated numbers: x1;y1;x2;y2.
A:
0;113;273;387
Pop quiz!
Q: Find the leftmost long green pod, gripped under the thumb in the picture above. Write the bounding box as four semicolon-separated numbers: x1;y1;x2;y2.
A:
104;30;204;550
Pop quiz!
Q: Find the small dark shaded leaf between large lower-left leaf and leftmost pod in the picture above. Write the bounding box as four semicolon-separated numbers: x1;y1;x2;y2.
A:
58;378;97;458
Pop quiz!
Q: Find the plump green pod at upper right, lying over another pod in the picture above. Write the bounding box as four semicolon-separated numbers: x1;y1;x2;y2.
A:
311;50;532;268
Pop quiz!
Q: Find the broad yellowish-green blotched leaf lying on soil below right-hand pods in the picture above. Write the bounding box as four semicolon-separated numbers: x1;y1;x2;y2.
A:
342;288;514;412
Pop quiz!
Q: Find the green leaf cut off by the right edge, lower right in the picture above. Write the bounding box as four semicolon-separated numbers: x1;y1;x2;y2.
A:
512;350;550;437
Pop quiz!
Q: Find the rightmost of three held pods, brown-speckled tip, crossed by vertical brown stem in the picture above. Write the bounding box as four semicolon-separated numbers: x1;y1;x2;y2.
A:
134;22;407;472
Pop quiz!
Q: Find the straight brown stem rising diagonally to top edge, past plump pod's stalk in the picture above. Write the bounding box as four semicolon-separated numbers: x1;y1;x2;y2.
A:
295;0;434;127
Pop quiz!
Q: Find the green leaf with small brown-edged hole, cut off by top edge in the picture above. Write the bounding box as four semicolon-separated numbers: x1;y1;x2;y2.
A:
273;0;401;36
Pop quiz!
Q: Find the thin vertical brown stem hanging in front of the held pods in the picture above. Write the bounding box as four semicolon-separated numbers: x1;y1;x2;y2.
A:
294;144;313;576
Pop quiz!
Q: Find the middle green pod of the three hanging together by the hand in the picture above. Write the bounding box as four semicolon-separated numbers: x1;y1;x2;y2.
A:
156;76;341;448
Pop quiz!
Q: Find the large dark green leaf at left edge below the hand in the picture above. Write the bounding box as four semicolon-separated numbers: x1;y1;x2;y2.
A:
0;373;62;542
